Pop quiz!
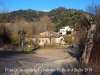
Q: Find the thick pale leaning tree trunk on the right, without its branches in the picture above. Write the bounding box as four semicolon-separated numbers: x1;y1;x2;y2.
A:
81;24;96;65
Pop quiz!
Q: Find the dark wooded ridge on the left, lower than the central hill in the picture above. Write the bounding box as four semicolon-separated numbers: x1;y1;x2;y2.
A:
0;9;44;22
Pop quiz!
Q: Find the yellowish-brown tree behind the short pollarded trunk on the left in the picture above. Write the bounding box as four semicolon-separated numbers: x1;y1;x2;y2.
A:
9;18;33;44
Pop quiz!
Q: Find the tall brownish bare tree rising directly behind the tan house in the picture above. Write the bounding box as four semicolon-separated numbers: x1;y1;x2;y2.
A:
32;15;54;36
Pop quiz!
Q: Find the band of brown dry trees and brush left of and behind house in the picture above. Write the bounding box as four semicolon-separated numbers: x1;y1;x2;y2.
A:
0;15;54;49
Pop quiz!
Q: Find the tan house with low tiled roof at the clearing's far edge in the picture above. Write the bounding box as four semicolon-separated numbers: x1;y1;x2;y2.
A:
36;31;65;47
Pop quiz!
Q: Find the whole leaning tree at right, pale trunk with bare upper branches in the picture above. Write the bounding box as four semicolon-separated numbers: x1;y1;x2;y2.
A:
81;3;100;65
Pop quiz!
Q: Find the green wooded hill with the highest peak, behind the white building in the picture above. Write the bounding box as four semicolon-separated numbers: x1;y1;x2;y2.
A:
48;7;85;31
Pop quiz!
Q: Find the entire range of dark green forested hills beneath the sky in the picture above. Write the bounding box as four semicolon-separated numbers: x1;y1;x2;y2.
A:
0;7;85;31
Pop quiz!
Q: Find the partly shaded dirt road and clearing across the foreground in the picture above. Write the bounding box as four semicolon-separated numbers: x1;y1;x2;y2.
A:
0;49;79;75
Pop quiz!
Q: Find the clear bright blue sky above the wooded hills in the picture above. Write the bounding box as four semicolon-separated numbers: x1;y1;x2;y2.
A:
2;0;100;11
